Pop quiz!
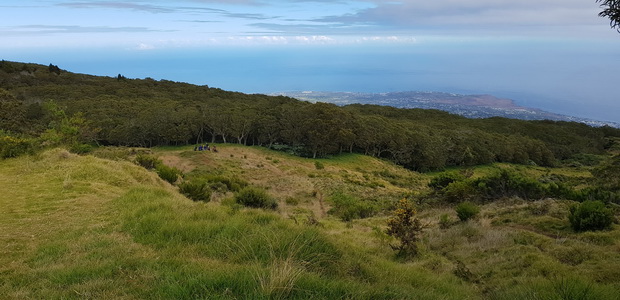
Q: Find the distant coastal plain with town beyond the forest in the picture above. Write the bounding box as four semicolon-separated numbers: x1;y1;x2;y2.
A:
273;91;620;128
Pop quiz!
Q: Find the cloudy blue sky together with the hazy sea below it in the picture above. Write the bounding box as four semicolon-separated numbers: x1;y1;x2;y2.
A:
0;0;620;122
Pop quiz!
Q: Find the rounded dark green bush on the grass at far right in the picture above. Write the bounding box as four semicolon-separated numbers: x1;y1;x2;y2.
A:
568;200;613;231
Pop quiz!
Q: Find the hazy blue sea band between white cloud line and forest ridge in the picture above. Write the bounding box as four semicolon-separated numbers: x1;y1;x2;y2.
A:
7;38;620;122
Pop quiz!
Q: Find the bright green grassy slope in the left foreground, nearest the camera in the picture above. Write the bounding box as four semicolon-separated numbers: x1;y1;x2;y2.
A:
0;150;478;299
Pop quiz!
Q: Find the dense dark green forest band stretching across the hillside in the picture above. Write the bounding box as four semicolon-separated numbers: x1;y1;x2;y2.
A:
0;61;620;171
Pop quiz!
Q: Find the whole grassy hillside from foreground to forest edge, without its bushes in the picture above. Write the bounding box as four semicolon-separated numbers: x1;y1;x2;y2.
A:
0;145;620;299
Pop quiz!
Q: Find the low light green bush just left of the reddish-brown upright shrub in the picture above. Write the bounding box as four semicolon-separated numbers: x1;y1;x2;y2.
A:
328;193;377;222
